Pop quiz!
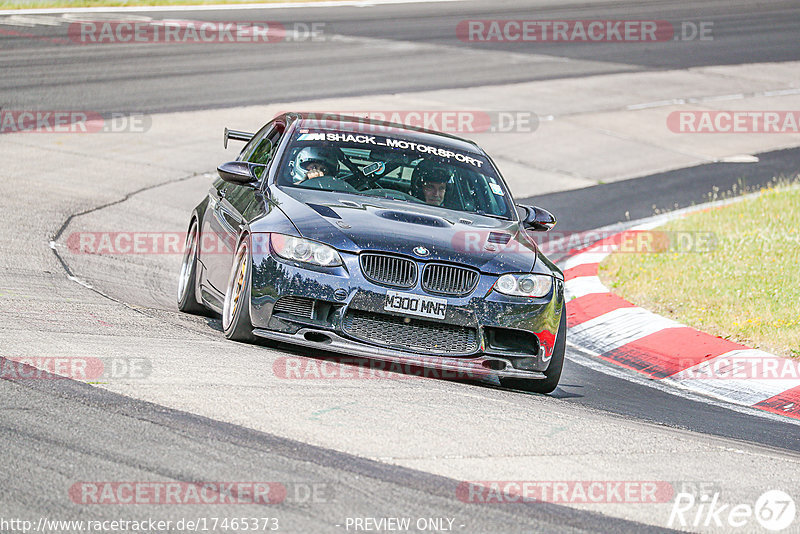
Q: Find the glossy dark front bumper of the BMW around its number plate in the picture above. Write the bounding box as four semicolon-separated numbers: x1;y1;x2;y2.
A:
250;245;564;379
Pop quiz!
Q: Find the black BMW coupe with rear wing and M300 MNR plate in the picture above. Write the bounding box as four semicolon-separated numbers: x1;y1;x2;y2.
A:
178;113;567;393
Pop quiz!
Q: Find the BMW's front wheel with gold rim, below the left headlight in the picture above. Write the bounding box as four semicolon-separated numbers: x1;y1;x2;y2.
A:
222;236;256;343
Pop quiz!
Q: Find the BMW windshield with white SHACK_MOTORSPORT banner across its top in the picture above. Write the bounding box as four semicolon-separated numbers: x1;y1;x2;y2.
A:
277;129;513;219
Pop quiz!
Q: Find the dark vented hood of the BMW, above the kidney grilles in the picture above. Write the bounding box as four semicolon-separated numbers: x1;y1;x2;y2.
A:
262;187;538;274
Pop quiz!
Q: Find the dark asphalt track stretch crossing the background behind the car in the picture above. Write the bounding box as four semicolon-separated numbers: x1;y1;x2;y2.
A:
0;1;800;113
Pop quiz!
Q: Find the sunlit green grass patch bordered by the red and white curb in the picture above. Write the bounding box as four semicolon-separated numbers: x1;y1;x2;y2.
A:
600;187;800;358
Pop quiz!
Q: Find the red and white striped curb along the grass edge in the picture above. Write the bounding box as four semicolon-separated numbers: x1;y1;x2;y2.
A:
560;203;800;419
